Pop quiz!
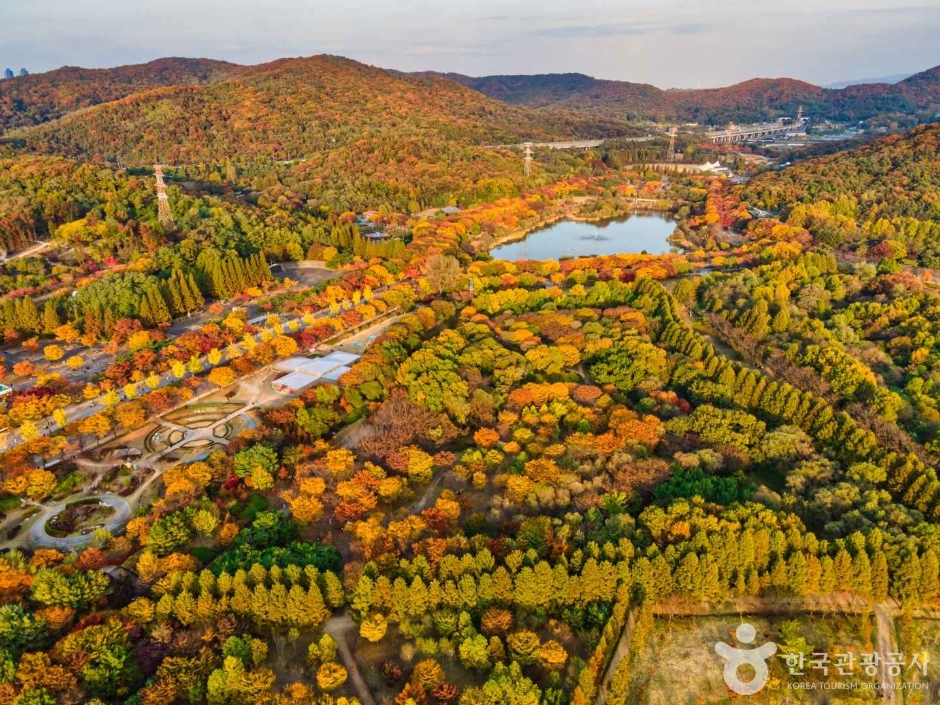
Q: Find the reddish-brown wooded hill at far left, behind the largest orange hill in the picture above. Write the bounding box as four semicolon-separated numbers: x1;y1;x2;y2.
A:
0;58;238;134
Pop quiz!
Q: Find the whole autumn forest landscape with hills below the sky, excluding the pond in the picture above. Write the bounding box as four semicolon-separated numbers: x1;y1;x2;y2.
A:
0;49;940;705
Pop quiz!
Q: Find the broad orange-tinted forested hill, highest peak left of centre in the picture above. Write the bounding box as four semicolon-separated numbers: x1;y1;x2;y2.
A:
7;56;624;166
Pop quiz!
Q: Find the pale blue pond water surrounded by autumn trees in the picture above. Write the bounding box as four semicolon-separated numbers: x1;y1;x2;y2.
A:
490;213;676;261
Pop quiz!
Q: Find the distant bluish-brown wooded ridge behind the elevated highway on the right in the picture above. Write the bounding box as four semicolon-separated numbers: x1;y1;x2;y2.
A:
419;67;940;124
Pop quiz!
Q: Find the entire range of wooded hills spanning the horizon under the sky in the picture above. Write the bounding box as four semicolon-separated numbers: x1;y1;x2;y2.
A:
9;56;940;164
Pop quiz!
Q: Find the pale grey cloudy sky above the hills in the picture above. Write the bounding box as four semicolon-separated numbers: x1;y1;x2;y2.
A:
0;0;940;88
